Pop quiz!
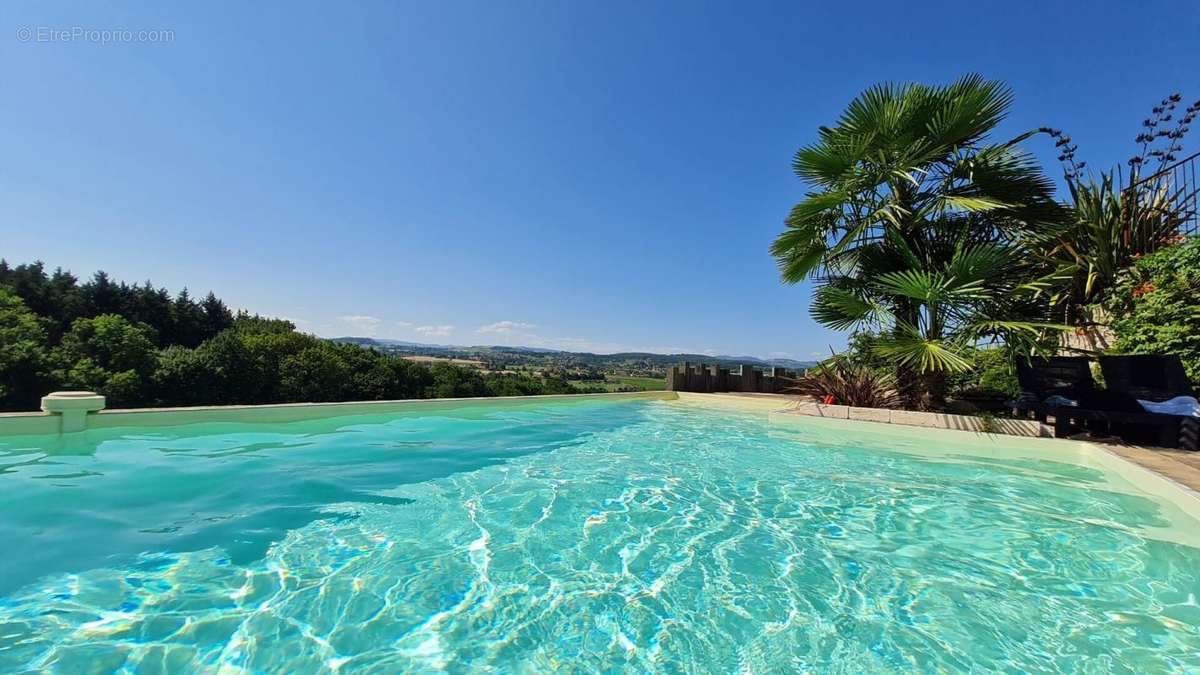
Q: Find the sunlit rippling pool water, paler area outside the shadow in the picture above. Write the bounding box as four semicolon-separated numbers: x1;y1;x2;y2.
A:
0;405;1200;673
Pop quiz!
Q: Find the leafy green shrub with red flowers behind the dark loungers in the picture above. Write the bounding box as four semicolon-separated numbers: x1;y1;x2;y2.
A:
1105;238;1200;382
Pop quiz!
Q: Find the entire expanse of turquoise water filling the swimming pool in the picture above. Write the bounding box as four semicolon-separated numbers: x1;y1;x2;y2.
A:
0;401;1200;673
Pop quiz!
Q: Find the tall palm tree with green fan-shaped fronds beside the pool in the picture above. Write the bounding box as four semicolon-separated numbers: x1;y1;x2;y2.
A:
772;74;1063;408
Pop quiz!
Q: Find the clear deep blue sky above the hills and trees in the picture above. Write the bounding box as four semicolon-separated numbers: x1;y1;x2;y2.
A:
0;0;1200;359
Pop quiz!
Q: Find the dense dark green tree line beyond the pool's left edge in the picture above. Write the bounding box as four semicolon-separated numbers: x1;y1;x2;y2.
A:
0;259;590;411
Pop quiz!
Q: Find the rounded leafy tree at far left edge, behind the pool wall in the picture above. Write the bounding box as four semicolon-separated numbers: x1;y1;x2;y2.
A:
0;287;50;410
